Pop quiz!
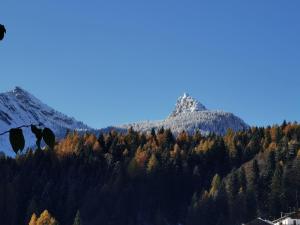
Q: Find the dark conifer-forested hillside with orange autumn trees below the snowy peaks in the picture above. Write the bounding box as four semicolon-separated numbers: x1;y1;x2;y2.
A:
0;122;300;225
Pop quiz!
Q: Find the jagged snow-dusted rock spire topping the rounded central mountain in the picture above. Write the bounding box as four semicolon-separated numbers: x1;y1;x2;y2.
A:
169;93;207;117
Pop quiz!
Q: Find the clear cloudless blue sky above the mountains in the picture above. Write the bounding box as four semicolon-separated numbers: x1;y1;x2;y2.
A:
0;0;300;127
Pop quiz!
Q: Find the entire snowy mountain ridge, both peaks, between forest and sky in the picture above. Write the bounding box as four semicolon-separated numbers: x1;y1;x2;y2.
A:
0;86;249;155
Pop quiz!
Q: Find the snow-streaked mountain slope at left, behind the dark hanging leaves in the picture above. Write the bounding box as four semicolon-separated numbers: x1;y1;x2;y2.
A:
0;87;91;155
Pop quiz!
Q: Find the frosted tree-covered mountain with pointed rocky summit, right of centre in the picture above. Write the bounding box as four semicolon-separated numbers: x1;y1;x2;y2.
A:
108;93;249;135
